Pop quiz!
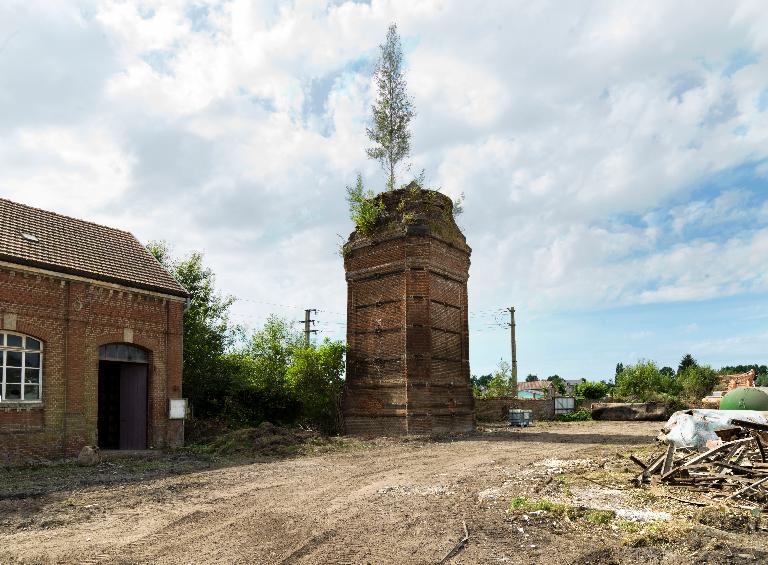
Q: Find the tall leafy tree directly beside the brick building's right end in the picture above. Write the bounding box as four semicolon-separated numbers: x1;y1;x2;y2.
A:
147;241;237;417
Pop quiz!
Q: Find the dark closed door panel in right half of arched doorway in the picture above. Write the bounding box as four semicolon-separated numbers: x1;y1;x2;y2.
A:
120;363;147;449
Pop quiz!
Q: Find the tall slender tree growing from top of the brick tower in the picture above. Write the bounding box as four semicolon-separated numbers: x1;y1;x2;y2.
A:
366;24;415;190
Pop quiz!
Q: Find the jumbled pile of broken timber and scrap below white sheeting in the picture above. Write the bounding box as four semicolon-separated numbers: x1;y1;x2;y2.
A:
631;418;768;508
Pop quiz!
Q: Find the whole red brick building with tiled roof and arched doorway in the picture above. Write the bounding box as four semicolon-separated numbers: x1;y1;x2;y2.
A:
0;199;187;462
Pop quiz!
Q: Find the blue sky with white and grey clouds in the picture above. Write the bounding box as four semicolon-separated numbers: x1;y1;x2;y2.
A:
0;0;768;379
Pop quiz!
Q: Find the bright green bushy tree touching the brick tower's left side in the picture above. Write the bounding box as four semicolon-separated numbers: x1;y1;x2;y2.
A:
287;338;345;433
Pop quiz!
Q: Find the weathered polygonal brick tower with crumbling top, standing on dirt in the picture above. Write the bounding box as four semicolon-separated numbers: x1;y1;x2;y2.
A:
344;184;474;435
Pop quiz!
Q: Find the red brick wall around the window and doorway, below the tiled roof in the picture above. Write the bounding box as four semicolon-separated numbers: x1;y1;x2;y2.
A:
0;267;183;462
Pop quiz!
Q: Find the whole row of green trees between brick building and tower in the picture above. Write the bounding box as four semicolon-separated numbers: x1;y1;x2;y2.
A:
147;242;345;433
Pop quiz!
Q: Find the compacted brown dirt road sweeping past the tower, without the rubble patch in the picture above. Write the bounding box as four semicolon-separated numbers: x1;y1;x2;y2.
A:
0;422;764;564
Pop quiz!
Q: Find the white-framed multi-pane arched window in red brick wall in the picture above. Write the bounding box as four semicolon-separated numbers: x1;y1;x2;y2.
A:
0;332;43;402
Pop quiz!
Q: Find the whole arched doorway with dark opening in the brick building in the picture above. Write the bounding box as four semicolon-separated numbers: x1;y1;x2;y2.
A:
98;343;149;449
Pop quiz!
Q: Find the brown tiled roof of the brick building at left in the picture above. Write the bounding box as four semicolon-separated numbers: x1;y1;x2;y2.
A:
0;198;187;296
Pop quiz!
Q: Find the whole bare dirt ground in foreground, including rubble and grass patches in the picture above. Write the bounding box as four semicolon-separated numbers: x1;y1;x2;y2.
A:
0;422;768;564
